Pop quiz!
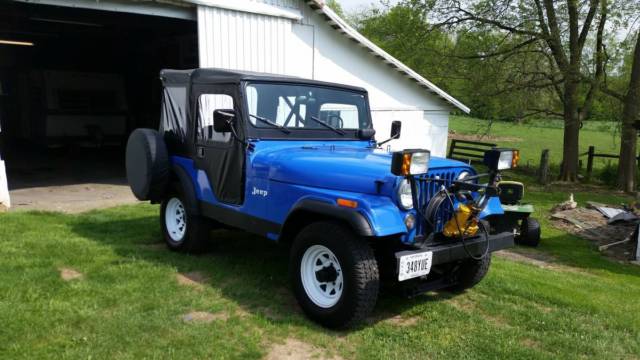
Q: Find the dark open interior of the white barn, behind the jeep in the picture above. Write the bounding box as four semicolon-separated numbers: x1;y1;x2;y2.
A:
0;1;198;205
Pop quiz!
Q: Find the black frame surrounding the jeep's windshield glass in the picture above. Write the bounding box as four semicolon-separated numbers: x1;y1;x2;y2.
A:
241;80;373;141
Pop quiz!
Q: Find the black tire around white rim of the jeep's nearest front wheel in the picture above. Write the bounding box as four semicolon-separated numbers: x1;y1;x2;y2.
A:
290;222;380;328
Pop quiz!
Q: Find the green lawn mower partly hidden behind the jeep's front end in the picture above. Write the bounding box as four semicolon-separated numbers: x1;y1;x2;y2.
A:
498;181;540;247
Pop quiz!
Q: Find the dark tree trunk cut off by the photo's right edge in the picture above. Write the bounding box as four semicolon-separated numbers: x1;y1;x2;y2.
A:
618;31;640;192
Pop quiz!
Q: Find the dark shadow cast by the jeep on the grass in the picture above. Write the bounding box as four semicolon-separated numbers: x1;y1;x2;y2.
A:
72;213;451;333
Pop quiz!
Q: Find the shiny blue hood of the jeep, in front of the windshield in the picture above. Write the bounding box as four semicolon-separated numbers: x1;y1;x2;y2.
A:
253;146;467;194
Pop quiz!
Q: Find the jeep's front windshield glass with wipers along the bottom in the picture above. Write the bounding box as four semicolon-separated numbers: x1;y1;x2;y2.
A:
246;83;371;139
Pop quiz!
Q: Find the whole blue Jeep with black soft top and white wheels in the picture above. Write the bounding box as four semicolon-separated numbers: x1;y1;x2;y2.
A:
126;69;519;328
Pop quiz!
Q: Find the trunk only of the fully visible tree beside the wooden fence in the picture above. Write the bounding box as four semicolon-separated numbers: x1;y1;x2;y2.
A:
560;72;580;181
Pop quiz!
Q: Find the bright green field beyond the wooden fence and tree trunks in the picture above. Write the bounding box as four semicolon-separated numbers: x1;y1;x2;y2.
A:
449;116;620;176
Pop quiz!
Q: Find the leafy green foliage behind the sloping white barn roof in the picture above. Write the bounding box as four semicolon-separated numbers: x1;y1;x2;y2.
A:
355;3;558;119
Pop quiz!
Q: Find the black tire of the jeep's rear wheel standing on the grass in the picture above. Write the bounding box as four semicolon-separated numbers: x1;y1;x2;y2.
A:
160;191;211;253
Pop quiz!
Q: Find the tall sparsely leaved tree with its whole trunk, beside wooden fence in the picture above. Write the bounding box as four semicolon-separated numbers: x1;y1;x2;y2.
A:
424;0;608;181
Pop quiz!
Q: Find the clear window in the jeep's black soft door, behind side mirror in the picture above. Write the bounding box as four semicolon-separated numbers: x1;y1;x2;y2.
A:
198;94;234;142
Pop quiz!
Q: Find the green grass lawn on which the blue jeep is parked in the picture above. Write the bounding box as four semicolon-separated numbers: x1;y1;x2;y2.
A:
0;183;640;359
